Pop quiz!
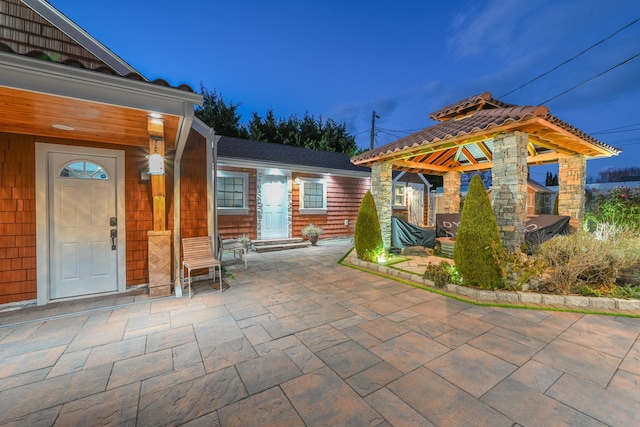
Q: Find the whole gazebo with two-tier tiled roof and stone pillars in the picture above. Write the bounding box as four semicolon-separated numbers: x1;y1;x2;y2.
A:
351;92;621;250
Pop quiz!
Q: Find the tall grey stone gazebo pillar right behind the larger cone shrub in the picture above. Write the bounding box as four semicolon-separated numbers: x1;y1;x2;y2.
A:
491;131;529;252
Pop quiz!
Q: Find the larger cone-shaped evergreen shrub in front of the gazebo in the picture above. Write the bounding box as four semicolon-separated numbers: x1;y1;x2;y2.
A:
453;175;505;289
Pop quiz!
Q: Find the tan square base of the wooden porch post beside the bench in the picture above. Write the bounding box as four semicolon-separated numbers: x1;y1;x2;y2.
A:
147;230;171;298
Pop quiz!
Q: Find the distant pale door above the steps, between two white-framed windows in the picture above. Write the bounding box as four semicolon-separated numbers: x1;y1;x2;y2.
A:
261;175;289;239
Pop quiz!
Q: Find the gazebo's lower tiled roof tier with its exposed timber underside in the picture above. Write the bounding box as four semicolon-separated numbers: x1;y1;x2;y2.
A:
351;103;620;175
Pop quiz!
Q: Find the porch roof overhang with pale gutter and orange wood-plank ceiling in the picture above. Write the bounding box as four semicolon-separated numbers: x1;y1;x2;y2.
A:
0;52;202;150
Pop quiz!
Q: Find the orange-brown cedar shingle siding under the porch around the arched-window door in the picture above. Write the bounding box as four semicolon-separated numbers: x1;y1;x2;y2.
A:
0;132;207;304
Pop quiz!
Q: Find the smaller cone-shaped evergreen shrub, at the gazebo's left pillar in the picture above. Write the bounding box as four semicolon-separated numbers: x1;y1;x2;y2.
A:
353;191;382;262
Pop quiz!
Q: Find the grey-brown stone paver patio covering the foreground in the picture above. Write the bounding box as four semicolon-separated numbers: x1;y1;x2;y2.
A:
0;241;640;426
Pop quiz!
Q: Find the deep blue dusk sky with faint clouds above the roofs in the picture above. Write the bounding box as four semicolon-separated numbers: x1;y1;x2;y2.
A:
50;0;640;182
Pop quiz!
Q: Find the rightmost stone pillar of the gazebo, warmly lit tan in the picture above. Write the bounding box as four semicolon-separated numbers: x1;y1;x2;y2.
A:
558;155;587;230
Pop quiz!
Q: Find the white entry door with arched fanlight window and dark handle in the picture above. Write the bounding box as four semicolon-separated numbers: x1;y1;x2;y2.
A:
48;153;119;299
